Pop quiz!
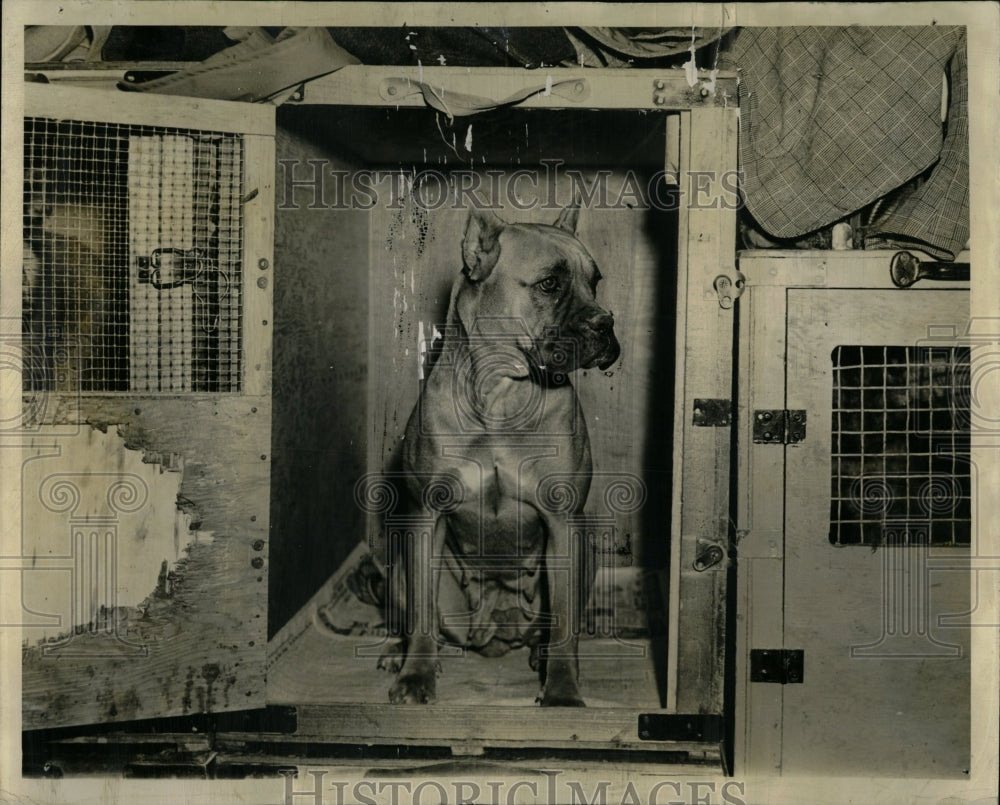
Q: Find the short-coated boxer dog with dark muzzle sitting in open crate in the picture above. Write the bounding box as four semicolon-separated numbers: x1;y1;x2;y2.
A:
379;203;620;707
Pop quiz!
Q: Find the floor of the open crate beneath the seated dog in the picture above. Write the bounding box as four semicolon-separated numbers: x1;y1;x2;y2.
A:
267;624;667;709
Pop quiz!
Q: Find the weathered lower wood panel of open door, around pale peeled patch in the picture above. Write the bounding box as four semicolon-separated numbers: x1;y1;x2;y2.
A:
22;395;270;729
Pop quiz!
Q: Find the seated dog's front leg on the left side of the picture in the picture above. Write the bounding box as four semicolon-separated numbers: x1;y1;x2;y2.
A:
389;515;447;704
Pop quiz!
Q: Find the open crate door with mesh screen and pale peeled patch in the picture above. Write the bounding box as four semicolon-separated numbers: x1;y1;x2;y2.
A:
19;84;274;730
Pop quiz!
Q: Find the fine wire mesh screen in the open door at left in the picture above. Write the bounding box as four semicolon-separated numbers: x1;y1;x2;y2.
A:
23;118;243;392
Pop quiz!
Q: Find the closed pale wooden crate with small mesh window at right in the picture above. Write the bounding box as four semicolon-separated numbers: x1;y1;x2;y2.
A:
735;251;968;779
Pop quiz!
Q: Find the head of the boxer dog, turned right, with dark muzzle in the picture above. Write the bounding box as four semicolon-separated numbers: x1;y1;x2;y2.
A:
455;204;621;373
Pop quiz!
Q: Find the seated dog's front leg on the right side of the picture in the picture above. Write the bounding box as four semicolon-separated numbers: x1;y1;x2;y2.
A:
541;515;588;707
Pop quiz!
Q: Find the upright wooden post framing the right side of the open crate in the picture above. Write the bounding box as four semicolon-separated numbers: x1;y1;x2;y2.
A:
672;108;737;713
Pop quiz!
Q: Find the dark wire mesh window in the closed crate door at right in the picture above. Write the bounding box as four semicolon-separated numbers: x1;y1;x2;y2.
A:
830;346;971;548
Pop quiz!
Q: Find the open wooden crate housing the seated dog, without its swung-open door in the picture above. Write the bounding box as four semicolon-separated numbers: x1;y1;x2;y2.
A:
267;67;736;765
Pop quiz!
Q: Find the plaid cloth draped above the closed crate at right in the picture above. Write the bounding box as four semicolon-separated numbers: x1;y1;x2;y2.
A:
728;26;969;259
